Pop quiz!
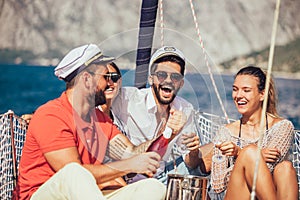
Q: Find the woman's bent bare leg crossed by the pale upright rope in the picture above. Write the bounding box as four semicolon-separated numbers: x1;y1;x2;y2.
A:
225;145;276;200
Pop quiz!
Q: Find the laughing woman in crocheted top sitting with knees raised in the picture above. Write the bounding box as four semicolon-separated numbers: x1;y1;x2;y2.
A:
212;66;298;200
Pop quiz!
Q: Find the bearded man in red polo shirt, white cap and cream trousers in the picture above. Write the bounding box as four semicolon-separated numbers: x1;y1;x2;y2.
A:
18;44;165;200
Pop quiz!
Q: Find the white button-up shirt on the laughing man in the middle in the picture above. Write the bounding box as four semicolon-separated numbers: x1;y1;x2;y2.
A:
112;87;196;162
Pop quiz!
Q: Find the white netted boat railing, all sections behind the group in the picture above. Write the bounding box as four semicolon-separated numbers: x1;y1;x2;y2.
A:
0;111;300;200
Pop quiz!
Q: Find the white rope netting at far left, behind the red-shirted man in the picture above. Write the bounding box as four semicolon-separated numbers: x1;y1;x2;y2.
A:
0;111;27;200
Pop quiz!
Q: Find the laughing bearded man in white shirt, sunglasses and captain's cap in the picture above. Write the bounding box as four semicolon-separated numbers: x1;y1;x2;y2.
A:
112;46;210;184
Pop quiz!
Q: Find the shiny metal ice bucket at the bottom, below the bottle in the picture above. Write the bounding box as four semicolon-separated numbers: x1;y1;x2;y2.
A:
166;174;208;200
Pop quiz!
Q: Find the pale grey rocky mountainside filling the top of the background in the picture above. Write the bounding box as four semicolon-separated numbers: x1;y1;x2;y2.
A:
0;0;300;74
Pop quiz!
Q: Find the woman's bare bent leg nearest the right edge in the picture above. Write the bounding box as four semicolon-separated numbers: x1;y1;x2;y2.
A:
273;161;298;200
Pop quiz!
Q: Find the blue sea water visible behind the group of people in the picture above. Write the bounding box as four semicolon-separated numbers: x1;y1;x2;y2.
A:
0;65;300;129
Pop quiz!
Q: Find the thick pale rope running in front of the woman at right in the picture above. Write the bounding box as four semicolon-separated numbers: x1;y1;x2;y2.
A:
251;0;280;200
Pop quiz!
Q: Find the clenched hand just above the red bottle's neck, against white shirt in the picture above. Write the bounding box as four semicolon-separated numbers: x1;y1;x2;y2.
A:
167;109;187;134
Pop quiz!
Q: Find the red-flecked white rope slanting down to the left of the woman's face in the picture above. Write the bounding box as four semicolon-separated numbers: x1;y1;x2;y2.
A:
189;0;230;123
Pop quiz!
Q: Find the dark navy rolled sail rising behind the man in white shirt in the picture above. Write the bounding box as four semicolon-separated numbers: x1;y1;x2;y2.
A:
134;0;158;88
